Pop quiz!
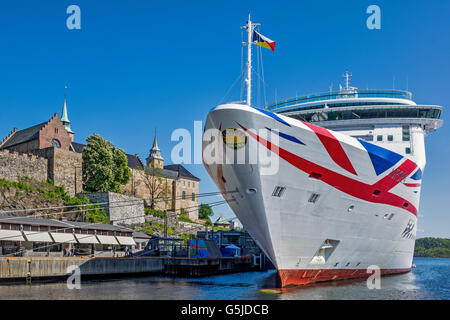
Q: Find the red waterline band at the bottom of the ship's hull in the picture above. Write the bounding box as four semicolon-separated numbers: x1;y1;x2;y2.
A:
278;268;411;287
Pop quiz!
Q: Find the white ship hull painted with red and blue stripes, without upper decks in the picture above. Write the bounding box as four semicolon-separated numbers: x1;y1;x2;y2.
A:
203;104;424;286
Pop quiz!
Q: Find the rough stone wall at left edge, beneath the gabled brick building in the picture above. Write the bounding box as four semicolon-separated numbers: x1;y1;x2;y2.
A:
0;150;48;182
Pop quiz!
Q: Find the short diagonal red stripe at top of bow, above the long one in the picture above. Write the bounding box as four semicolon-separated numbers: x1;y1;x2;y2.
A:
303;122;356;175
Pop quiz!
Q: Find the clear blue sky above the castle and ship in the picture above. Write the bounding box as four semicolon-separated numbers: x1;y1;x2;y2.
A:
0;0;450;237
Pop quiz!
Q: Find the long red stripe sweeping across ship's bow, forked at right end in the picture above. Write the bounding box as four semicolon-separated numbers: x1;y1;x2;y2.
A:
238;123;417;216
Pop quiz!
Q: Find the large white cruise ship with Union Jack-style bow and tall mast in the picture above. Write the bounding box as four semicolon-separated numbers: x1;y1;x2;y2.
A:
203;18;443;287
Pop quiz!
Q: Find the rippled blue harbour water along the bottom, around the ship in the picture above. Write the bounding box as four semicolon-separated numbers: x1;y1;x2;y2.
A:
0;258;450;300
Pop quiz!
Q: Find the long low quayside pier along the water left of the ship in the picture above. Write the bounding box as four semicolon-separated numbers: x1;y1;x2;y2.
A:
0;256;260;282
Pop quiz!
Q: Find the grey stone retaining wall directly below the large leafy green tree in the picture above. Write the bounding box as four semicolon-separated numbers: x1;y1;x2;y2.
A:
79;192;145;225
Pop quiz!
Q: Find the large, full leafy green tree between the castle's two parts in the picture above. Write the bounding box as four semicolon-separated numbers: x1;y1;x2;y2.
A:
83;134;131;192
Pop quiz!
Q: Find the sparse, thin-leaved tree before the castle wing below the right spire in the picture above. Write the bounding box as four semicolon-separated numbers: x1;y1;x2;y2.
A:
144;162;169;209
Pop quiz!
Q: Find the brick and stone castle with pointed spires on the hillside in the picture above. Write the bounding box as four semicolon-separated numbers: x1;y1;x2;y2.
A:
0;95;200;220
